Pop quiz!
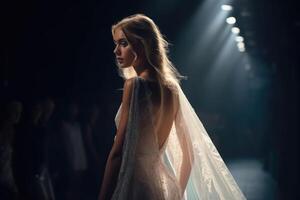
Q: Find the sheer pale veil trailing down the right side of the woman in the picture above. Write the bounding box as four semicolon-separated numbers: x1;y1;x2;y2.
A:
164;82;246;200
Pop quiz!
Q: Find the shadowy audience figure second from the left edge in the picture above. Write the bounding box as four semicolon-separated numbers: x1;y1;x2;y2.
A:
13;102;44;200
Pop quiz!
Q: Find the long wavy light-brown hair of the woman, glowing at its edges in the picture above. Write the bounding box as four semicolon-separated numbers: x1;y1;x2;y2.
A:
112;14;184;88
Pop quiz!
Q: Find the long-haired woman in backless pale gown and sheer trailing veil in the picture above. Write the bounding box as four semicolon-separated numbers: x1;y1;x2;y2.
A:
99;14;245;200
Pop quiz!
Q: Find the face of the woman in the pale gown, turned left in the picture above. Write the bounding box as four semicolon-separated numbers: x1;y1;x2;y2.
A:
113;28;136;68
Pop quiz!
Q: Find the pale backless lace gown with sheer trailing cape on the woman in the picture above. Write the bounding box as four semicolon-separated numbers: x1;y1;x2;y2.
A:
112;67;246;200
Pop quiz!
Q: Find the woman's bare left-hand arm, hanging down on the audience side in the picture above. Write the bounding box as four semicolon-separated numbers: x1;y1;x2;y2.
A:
98;79;134;200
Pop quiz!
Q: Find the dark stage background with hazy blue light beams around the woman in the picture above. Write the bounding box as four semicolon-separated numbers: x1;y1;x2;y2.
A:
0;0;300;200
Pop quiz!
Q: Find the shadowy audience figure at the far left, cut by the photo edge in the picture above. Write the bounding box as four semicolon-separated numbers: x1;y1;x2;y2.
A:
0;101;22;200
